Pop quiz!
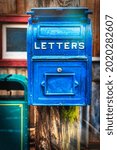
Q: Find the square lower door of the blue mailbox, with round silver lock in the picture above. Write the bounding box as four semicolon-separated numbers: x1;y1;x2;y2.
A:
29;61;87;105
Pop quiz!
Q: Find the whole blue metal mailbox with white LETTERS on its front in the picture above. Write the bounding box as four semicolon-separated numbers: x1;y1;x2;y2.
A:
27;7;92;106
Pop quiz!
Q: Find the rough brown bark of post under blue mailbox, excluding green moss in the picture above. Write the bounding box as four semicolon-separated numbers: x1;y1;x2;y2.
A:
36;106;80;150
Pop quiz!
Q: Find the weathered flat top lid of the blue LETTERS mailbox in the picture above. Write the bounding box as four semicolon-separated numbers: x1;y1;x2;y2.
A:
27;7;92;18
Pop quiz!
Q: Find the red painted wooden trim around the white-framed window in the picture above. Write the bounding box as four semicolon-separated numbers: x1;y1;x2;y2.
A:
0;15;30;67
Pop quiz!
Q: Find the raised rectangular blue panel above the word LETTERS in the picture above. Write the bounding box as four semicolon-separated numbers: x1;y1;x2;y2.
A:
37;23;85;39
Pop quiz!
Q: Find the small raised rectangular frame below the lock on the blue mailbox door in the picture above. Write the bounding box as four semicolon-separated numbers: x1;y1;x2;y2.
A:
41;73;79;96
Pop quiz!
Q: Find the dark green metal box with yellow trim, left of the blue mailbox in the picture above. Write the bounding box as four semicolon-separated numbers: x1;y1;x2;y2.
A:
0;74;28;150
